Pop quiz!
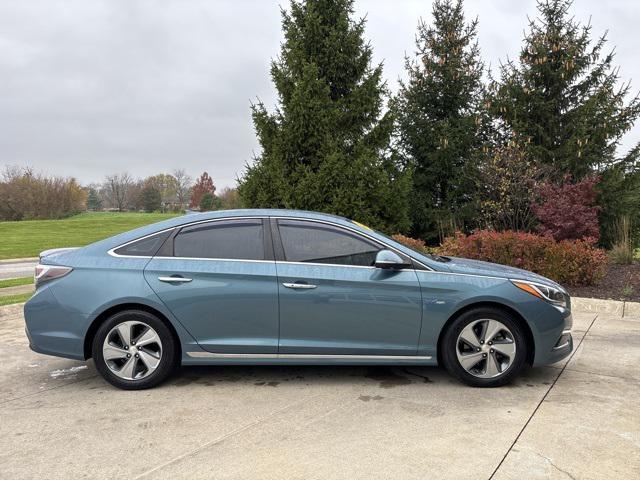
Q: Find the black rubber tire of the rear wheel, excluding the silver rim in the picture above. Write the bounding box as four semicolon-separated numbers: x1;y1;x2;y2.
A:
91;310;178;390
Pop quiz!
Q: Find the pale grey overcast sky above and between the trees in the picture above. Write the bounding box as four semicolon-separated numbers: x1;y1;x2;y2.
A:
0;0;640;187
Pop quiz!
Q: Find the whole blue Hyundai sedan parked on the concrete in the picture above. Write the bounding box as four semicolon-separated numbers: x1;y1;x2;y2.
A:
24;210;573;389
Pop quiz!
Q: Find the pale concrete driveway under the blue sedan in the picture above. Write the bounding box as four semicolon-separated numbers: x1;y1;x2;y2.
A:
0;306;640;480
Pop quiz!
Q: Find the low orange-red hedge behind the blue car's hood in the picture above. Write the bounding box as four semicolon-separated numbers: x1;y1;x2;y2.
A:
438;230;607;286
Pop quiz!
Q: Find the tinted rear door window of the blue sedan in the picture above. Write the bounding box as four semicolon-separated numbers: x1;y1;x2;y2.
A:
173;220;264;260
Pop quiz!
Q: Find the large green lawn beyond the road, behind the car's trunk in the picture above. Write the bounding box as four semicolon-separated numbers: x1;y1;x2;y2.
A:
0;212;177;259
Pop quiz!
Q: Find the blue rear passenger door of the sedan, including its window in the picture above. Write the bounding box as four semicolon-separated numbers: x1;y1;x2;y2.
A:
145;218;278;353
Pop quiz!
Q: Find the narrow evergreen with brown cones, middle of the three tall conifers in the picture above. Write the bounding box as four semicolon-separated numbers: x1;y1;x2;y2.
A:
395;0;485;242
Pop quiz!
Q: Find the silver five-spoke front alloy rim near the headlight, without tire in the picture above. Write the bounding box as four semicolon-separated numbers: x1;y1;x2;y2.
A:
456;319;516;378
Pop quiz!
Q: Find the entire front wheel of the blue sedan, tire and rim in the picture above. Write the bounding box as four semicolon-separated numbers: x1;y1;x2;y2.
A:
441;307;527;387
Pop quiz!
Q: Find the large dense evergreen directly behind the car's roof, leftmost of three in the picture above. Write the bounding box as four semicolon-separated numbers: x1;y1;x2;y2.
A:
238;0;409;232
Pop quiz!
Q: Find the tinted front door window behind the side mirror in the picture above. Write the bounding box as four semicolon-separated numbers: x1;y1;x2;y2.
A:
278;220;382;266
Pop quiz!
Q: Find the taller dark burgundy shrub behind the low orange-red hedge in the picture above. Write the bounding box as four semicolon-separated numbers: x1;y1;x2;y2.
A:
531;176;600;243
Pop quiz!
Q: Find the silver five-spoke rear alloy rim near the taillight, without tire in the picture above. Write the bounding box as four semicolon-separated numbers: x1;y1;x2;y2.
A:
102;321;162;380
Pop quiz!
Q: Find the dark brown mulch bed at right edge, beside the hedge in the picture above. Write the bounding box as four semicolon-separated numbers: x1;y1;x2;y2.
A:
569;262;640;302
